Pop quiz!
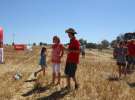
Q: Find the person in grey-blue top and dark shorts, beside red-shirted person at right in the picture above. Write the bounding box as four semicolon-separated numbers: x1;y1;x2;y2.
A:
116;41;127;78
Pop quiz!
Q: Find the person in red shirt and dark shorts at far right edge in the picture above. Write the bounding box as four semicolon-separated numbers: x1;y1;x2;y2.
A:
127;39;135;69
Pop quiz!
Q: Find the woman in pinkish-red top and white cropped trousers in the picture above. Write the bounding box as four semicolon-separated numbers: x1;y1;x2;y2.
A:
52;36;64;85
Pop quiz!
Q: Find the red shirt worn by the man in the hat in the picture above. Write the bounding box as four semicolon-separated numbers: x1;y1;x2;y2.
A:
67;37;80;64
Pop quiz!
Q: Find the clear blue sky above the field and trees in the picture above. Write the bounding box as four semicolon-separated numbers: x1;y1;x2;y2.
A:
0;0;135;43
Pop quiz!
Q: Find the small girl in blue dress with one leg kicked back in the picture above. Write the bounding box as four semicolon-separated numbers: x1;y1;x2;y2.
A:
34;47;47;77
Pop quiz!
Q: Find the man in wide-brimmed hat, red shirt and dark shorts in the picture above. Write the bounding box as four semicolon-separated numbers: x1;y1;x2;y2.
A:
65;28;80;89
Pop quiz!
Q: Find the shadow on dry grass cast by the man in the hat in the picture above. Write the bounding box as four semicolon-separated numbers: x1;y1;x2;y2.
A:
37;88;70;100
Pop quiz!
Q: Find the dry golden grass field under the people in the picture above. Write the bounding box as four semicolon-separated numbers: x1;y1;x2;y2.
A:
0;47;135;100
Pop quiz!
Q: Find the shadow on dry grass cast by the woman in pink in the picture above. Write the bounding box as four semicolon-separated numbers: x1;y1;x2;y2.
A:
22;86;49;97
